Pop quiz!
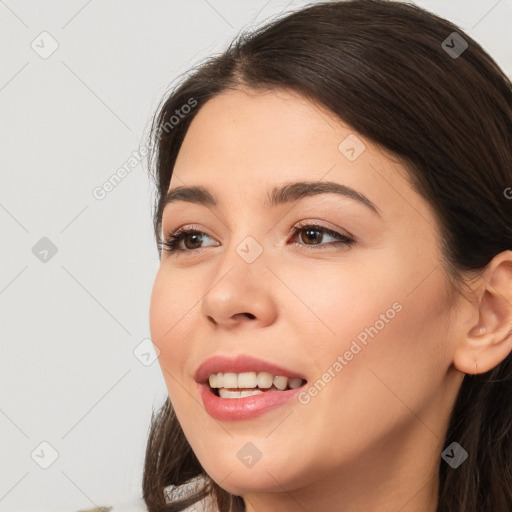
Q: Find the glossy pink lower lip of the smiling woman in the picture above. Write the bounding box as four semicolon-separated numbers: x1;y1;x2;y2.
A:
197;383;304;421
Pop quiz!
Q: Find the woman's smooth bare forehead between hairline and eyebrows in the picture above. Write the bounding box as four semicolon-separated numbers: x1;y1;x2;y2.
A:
169;90;431;226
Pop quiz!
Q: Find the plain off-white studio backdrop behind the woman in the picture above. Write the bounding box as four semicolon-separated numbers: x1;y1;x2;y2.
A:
0;0;512;512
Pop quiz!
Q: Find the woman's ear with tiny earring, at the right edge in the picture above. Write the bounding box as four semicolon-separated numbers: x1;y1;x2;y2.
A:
453;251;512;374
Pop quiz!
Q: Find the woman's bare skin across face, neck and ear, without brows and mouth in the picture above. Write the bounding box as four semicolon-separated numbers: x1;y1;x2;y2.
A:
150;89;512;512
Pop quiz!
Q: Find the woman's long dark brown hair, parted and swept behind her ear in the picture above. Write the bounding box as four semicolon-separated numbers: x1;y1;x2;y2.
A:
142;0;512;512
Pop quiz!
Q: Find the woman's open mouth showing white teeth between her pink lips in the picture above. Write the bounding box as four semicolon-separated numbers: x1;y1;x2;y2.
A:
208;372;307;398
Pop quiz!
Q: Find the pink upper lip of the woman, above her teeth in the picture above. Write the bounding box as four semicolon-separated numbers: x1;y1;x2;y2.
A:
194;354;307;384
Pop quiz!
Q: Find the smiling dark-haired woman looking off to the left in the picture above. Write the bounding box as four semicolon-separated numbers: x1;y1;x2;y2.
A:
143;0;512;512
